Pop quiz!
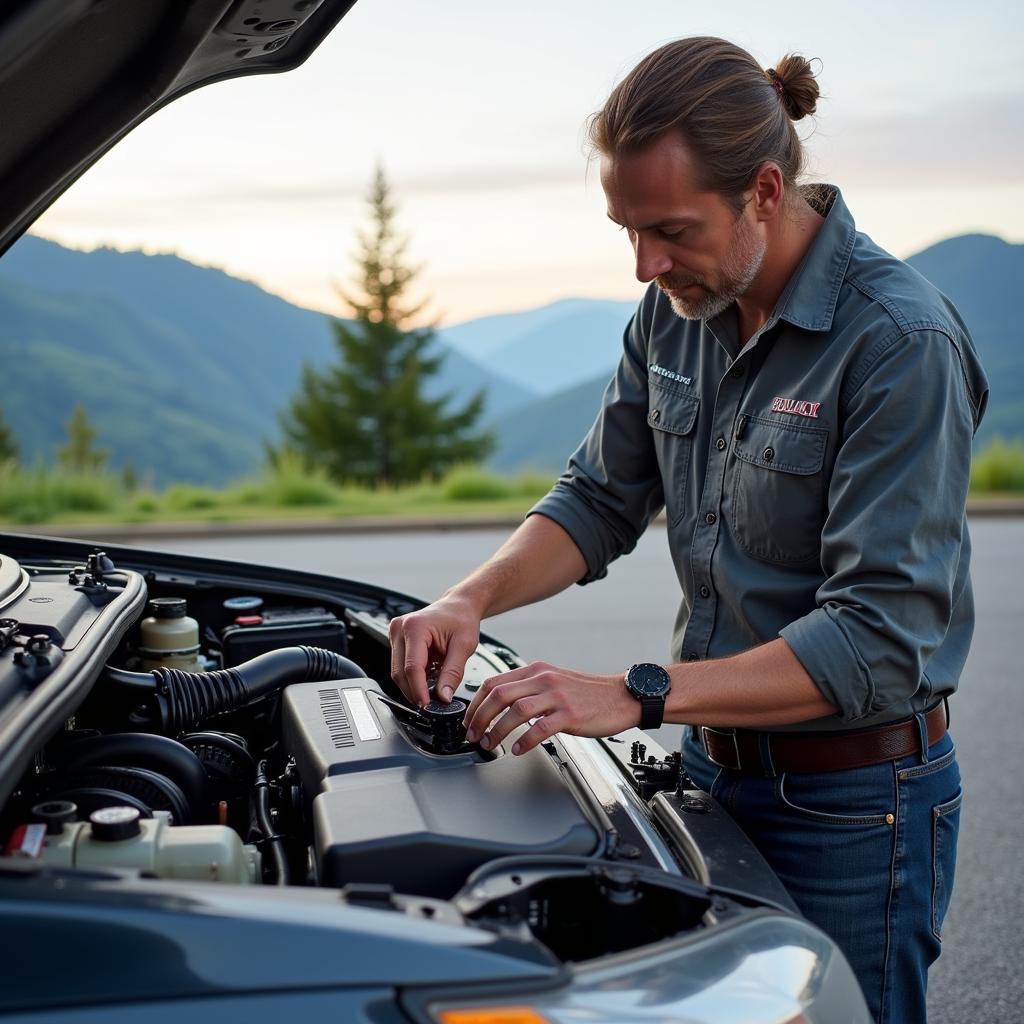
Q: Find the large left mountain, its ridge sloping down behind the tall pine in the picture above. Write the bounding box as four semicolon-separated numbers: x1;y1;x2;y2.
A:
0;236;532;484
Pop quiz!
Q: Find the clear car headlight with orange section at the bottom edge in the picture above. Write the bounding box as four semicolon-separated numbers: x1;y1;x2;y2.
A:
415;913;871;1024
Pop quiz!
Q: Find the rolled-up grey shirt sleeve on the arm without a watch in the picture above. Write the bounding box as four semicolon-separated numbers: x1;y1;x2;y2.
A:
528;307;665;584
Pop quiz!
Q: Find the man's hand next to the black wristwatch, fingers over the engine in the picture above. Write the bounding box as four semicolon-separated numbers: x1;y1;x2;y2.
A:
465;662;640;754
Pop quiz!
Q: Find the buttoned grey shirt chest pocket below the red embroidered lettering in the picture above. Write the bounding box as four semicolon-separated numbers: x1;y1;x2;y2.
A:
732;416;828;564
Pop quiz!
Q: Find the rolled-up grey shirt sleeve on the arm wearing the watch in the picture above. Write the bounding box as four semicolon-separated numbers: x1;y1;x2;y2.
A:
779;330;978;722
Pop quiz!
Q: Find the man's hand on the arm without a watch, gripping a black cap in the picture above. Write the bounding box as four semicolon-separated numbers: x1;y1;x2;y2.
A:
388;596;481;708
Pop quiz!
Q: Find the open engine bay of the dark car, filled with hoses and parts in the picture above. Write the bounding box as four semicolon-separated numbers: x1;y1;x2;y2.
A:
0;539;774;961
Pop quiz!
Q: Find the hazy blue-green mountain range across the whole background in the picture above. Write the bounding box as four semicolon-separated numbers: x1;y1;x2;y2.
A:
0;234;1024;484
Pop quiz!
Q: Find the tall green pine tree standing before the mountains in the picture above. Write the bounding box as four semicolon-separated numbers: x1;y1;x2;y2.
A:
281;168;494;484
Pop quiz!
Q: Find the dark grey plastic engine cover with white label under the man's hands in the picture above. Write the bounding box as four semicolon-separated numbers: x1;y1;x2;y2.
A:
283;679;598;898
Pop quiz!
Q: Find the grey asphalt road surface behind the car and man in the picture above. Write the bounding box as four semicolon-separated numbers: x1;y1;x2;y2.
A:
153;519;1024;1024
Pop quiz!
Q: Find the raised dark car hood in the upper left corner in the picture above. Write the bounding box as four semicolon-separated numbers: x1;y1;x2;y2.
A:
0;0;354;253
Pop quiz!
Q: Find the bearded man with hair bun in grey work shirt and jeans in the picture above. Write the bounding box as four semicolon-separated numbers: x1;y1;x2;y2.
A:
391;38;987;1024
